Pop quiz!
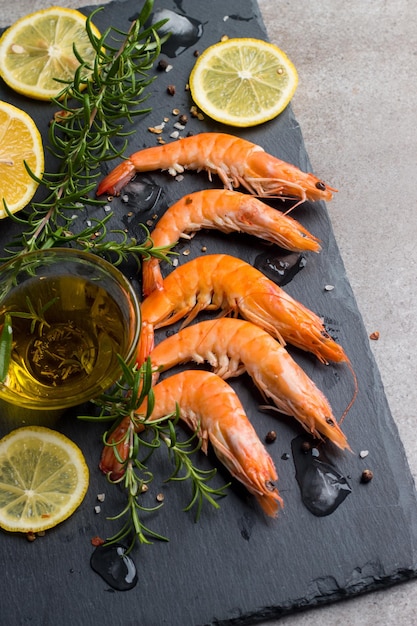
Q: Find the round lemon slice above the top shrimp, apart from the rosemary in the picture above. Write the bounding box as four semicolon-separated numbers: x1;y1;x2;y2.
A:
190;38;298;127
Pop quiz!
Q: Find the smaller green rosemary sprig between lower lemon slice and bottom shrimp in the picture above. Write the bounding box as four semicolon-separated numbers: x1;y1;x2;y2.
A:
79;360;228;552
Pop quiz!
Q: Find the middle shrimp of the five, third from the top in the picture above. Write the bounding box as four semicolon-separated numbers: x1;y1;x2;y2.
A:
141;254;349;363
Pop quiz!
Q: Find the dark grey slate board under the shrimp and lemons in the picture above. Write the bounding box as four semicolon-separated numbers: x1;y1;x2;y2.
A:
0;0;417;626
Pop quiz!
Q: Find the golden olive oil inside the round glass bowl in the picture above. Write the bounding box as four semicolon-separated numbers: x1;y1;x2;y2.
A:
0;274;131;407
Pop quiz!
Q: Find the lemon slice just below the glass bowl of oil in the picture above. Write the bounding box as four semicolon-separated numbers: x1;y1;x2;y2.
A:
0;426;89;533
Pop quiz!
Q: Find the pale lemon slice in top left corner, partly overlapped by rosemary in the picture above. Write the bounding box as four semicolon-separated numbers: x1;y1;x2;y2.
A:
0;7;100;100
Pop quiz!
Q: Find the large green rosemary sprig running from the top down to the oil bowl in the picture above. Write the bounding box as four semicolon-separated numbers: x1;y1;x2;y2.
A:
3;0;169;263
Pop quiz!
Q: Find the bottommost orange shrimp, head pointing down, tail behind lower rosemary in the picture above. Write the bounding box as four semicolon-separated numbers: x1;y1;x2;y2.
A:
100;370;283;517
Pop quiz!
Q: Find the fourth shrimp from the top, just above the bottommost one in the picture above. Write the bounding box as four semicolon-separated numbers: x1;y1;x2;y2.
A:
146;318;350;450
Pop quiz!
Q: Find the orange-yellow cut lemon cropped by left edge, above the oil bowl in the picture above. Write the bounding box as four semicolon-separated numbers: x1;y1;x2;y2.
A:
0;101;44;219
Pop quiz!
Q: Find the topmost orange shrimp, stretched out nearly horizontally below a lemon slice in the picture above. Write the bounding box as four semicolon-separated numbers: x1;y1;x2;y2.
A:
97;133;337;204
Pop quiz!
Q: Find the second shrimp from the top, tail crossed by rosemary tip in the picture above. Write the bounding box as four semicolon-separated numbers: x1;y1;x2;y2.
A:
142;189;320;295
